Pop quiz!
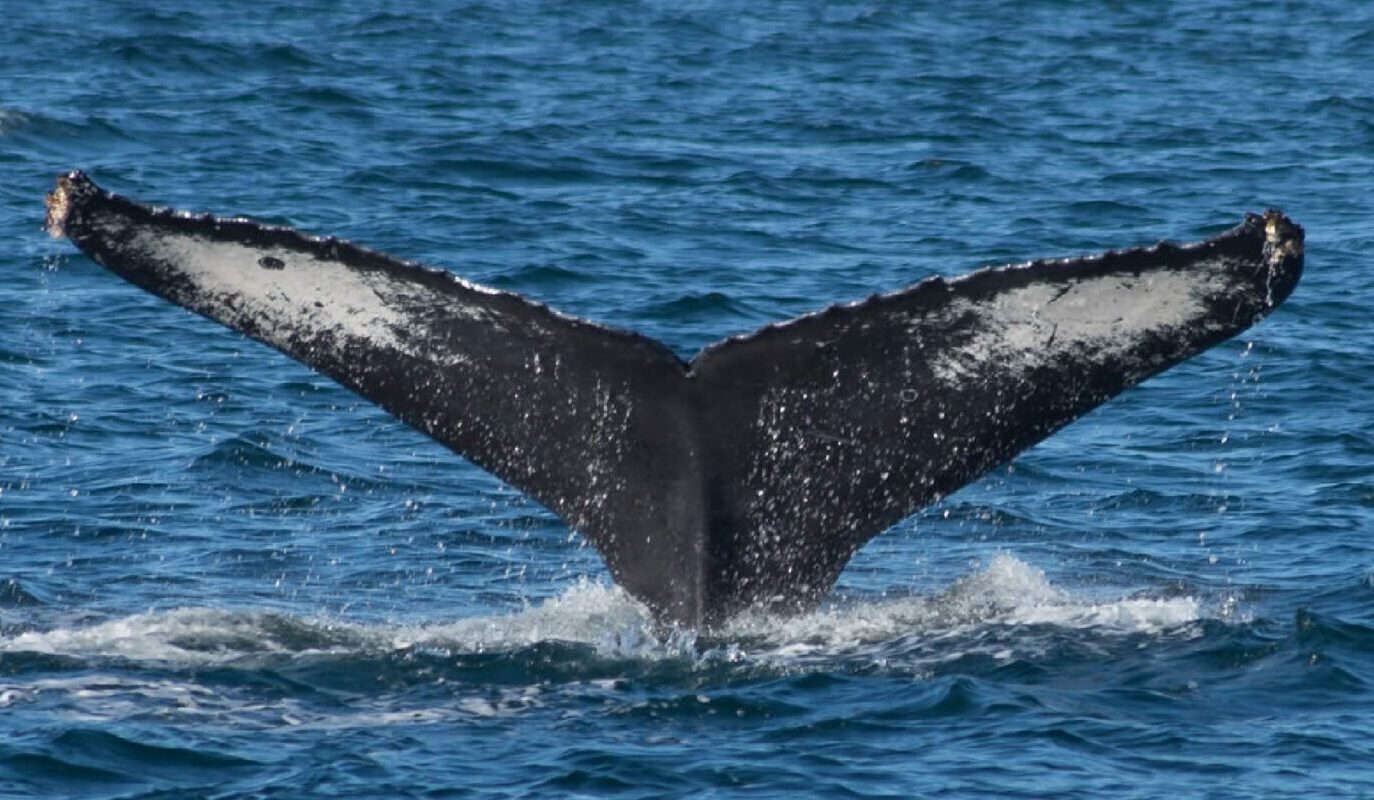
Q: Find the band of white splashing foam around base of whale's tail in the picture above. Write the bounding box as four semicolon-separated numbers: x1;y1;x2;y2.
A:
0;554;1204;667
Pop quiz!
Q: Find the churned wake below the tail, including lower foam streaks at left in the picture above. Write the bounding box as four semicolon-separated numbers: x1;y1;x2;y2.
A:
0;554;1231;742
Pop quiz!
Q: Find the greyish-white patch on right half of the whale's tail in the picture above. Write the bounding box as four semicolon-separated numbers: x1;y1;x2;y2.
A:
912;261;1231;382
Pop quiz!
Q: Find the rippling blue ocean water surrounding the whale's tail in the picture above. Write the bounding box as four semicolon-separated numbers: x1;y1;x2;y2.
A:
0;0;1374;799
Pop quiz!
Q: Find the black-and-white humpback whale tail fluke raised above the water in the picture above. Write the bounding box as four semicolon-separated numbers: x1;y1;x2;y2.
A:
47;172;1303;625
